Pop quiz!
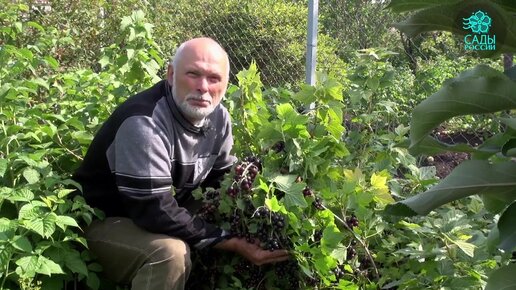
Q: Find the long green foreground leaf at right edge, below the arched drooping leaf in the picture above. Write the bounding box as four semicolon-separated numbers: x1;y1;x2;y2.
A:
386;160;516;216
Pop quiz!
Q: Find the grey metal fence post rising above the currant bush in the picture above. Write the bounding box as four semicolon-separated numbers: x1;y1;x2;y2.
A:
306;0;319;86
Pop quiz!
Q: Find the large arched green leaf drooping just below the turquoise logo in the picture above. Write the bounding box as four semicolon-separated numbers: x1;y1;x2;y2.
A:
409;65;516;153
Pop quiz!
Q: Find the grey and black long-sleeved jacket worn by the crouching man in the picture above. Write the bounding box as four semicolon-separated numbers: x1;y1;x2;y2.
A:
73;81;235;249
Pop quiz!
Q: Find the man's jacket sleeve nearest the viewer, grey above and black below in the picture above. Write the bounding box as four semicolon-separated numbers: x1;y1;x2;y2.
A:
107;116;227;248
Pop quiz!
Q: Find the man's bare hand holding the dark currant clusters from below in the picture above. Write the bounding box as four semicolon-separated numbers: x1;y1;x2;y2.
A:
214;238;289;266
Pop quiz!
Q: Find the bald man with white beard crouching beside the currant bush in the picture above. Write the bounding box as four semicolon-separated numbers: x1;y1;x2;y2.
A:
74;38;288;290
